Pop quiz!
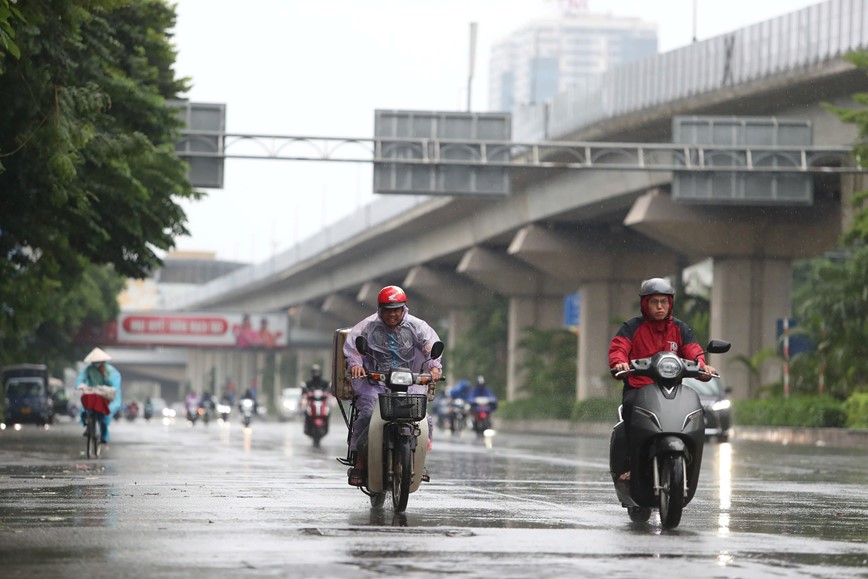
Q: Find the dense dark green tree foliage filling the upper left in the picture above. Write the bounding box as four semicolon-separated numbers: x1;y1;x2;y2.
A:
0;0;199;370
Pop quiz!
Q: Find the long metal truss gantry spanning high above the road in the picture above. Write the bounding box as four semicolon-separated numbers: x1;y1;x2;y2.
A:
179;131;866;173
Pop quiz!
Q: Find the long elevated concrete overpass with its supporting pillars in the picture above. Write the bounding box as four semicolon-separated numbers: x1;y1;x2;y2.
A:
177;0;868;398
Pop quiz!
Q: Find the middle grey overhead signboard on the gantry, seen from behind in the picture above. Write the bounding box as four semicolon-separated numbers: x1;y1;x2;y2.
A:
374;110;512;197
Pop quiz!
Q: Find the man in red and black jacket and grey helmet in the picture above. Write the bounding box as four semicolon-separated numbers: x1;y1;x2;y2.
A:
609;277;716;480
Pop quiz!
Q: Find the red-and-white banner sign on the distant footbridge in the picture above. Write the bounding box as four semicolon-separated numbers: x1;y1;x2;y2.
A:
116;311;289;349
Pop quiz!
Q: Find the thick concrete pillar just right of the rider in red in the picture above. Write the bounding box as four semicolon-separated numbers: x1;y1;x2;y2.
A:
703;258;792;399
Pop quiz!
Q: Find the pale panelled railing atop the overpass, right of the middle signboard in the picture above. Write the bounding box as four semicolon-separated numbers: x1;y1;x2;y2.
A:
513;0;868;141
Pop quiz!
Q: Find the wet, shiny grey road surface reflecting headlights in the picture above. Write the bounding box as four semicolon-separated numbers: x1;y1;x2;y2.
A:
0;416;868;578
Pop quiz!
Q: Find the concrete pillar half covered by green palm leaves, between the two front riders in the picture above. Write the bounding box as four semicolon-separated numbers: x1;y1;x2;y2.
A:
506;296;563;400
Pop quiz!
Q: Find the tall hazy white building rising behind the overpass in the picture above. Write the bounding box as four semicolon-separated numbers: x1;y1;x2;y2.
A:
488;0;657;112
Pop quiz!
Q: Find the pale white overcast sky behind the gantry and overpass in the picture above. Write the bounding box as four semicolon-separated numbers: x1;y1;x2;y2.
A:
174;0;818;262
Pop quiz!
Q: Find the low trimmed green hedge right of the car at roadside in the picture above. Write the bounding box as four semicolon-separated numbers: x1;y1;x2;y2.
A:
733;396;847;427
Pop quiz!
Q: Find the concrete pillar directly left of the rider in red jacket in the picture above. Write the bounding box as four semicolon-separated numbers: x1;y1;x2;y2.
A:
576;281;639;400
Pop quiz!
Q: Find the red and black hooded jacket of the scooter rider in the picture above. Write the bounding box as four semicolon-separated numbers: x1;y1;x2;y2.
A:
609;296;705;388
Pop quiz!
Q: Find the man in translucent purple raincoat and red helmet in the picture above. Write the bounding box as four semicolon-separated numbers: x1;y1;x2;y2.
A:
344;286;442;486
